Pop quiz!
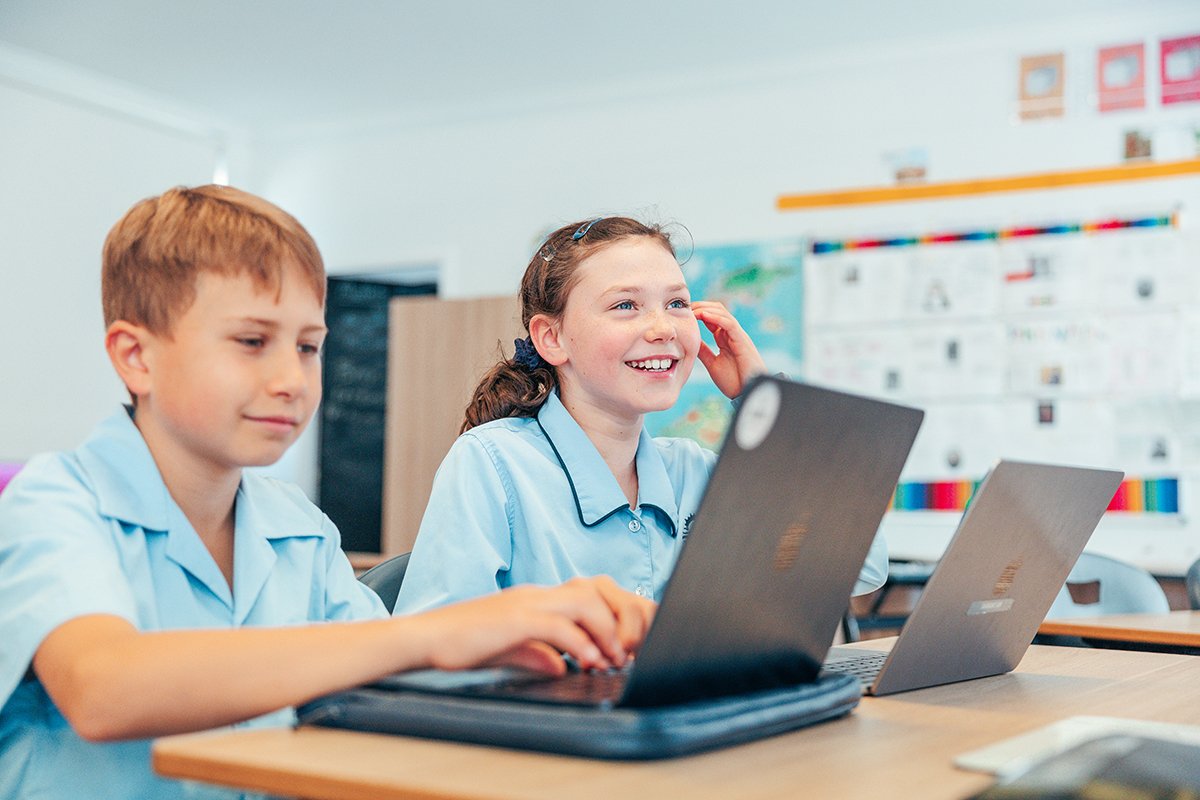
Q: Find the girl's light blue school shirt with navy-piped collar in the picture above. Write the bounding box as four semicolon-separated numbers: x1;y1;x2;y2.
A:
395;392;887;614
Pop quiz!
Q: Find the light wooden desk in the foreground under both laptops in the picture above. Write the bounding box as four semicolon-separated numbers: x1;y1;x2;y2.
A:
154;639;1200;800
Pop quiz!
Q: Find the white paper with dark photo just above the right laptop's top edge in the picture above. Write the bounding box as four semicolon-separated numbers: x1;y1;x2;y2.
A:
1001;397;1121;469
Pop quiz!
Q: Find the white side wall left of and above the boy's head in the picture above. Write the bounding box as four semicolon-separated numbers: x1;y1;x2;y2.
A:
0;62;220;461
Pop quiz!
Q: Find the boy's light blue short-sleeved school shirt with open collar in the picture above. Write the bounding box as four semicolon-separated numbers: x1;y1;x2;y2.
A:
0;410;386;800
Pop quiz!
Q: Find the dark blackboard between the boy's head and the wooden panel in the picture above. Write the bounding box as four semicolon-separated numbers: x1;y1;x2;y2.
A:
318;277;437;553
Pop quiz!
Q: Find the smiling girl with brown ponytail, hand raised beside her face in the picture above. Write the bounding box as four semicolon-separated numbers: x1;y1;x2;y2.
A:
396;217;887;613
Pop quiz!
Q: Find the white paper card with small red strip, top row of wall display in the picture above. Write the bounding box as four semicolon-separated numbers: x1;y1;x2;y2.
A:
1000;236;1094;312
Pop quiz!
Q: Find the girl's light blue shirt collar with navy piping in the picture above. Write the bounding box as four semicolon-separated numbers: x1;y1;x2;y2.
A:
538;392;678;536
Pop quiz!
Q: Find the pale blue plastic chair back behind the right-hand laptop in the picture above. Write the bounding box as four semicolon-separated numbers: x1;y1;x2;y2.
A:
1046;553;1171;619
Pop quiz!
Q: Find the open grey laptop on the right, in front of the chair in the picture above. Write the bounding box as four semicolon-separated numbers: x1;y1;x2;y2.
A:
826;461;1124;694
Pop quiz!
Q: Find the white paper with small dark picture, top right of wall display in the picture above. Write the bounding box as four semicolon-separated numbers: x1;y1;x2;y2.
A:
1086;229;1196;311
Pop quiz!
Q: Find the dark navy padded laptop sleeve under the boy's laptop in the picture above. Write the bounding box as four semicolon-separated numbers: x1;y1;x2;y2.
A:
299;675;862;759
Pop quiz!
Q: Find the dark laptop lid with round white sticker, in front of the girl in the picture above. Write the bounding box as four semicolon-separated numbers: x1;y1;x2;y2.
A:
620;378;924;706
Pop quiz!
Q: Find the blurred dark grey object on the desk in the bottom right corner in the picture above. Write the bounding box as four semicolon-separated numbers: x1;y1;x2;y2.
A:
968;735;1200;800
